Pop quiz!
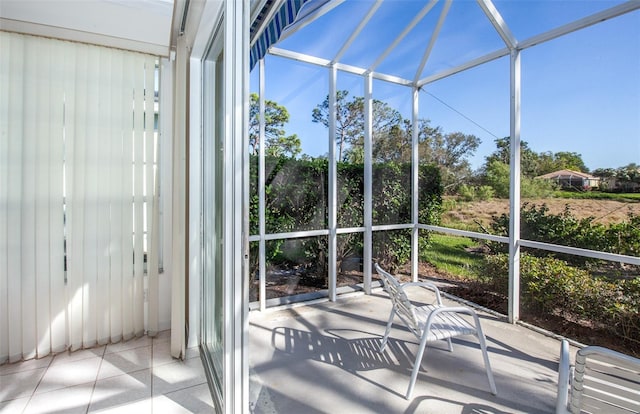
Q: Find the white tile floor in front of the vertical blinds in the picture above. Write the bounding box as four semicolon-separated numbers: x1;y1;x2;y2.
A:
0;331;214;414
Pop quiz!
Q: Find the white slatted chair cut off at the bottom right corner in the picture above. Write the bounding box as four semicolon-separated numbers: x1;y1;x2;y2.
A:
556;340;640;414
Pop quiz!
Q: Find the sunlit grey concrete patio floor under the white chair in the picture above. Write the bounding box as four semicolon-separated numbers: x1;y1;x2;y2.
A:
249;288;576;414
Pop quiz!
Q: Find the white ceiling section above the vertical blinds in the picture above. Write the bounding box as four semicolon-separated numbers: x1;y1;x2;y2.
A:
0;0;174;56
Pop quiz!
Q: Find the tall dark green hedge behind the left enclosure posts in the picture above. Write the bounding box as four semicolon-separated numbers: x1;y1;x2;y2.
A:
249;157;442;274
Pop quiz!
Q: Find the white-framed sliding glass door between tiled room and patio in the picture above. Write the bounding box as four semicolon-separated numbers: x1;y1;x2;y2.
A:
199;0;249;414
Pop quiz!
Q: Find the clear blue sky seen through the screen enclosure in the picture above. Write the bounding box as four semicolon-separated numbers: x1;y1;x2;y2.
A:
251;0;640;170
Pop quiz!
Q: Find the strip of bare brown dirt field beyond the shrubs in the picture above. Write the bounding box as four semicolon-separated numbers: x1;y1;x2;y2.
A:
442;198;640;226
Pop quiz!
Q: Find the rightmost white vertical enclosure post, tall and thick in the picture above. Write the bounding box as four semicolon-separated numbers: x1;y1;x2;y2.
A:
508;50;521;323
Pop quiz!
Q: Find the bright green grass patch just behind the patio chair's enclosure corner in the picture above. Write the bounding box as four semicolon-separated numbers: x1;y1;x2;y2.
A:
420;233;482;278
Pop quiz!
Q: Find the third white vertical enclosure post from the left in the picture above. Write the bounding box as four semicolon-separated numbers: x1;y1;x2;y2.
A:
362;73;373;295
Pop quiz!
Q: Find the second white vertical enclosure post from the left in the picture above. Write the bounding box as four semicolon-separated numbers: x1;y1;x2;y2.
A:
328;65;338;302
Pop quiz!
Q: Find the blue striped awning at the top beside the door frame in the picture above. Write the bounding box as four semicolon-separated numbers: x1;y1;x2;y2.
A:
249;0;330;70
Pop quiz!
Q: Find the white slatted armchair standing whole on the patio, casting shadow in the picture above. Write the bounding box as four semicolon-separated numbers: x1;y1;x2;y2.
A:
375;263;497;399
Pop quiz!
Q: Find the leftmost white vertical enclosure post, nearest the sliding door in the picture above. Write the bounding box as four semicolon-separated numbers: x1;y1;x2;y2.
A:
258;58;267;311
